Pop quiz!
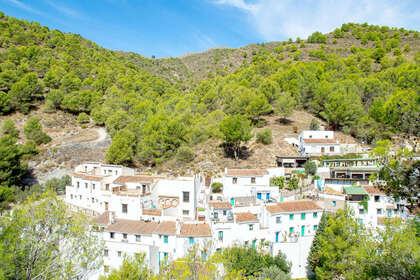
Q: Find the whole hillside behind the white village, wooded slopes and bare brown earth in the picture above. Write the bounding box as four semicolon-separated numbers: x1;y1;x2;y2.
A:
0;11;420;184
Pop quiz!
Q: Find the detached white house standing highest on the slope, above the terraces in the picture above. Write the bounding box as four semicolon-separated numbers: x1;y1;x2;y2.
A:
298;130;341;156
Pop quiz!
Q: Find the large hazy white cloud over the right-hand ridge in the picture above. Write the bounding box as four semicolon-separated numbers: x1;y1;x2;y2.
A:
213;0;420;41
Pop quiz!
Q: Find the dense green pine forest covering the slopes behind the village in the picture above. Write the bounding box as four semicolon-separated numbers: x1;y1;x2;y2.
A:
0;10;420;171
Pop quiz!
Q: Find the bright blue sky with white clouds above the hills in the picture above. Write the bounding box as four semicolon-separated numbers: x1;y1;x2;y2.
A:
0;0;420;57
